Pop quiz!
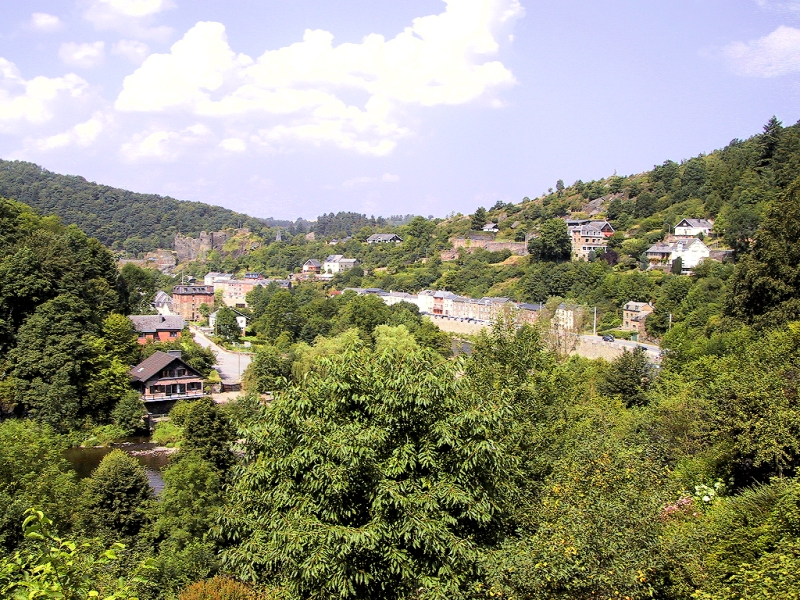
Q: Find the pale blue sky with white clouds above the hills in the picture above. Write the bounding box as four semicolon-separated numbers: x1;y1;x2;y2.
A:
0;0;800;219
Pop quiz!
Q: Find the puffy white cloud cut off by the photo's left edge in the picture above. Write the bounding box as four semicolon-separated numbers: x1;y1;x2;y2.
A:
0;58;89;132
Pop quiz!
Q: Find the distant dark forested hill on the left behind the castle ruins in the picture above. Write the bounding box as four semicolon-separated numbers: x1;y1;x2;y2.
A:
0;160;291;252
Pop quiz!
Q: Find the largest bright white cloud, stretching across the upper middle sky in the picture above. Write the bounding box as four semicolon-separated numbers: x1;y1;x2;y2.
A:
115;0;524;156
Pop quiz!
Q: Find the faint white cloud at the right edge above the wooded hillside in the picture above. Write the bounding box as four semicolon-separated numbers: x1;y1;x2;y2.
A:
723;25;800;77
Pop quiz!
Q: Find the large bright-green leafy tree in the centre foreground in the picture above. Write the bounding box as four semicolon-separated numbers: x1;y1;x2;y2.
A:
216;346;507;599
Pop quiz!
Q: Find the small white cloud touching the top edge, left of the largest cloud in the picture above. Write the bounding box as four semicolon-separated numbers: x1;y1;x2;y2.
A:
83;0;175;40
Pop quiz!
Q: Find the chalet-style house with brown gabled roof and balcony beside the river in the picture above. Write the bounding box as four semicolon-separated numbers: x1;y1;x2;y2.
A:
129;350;204;414
